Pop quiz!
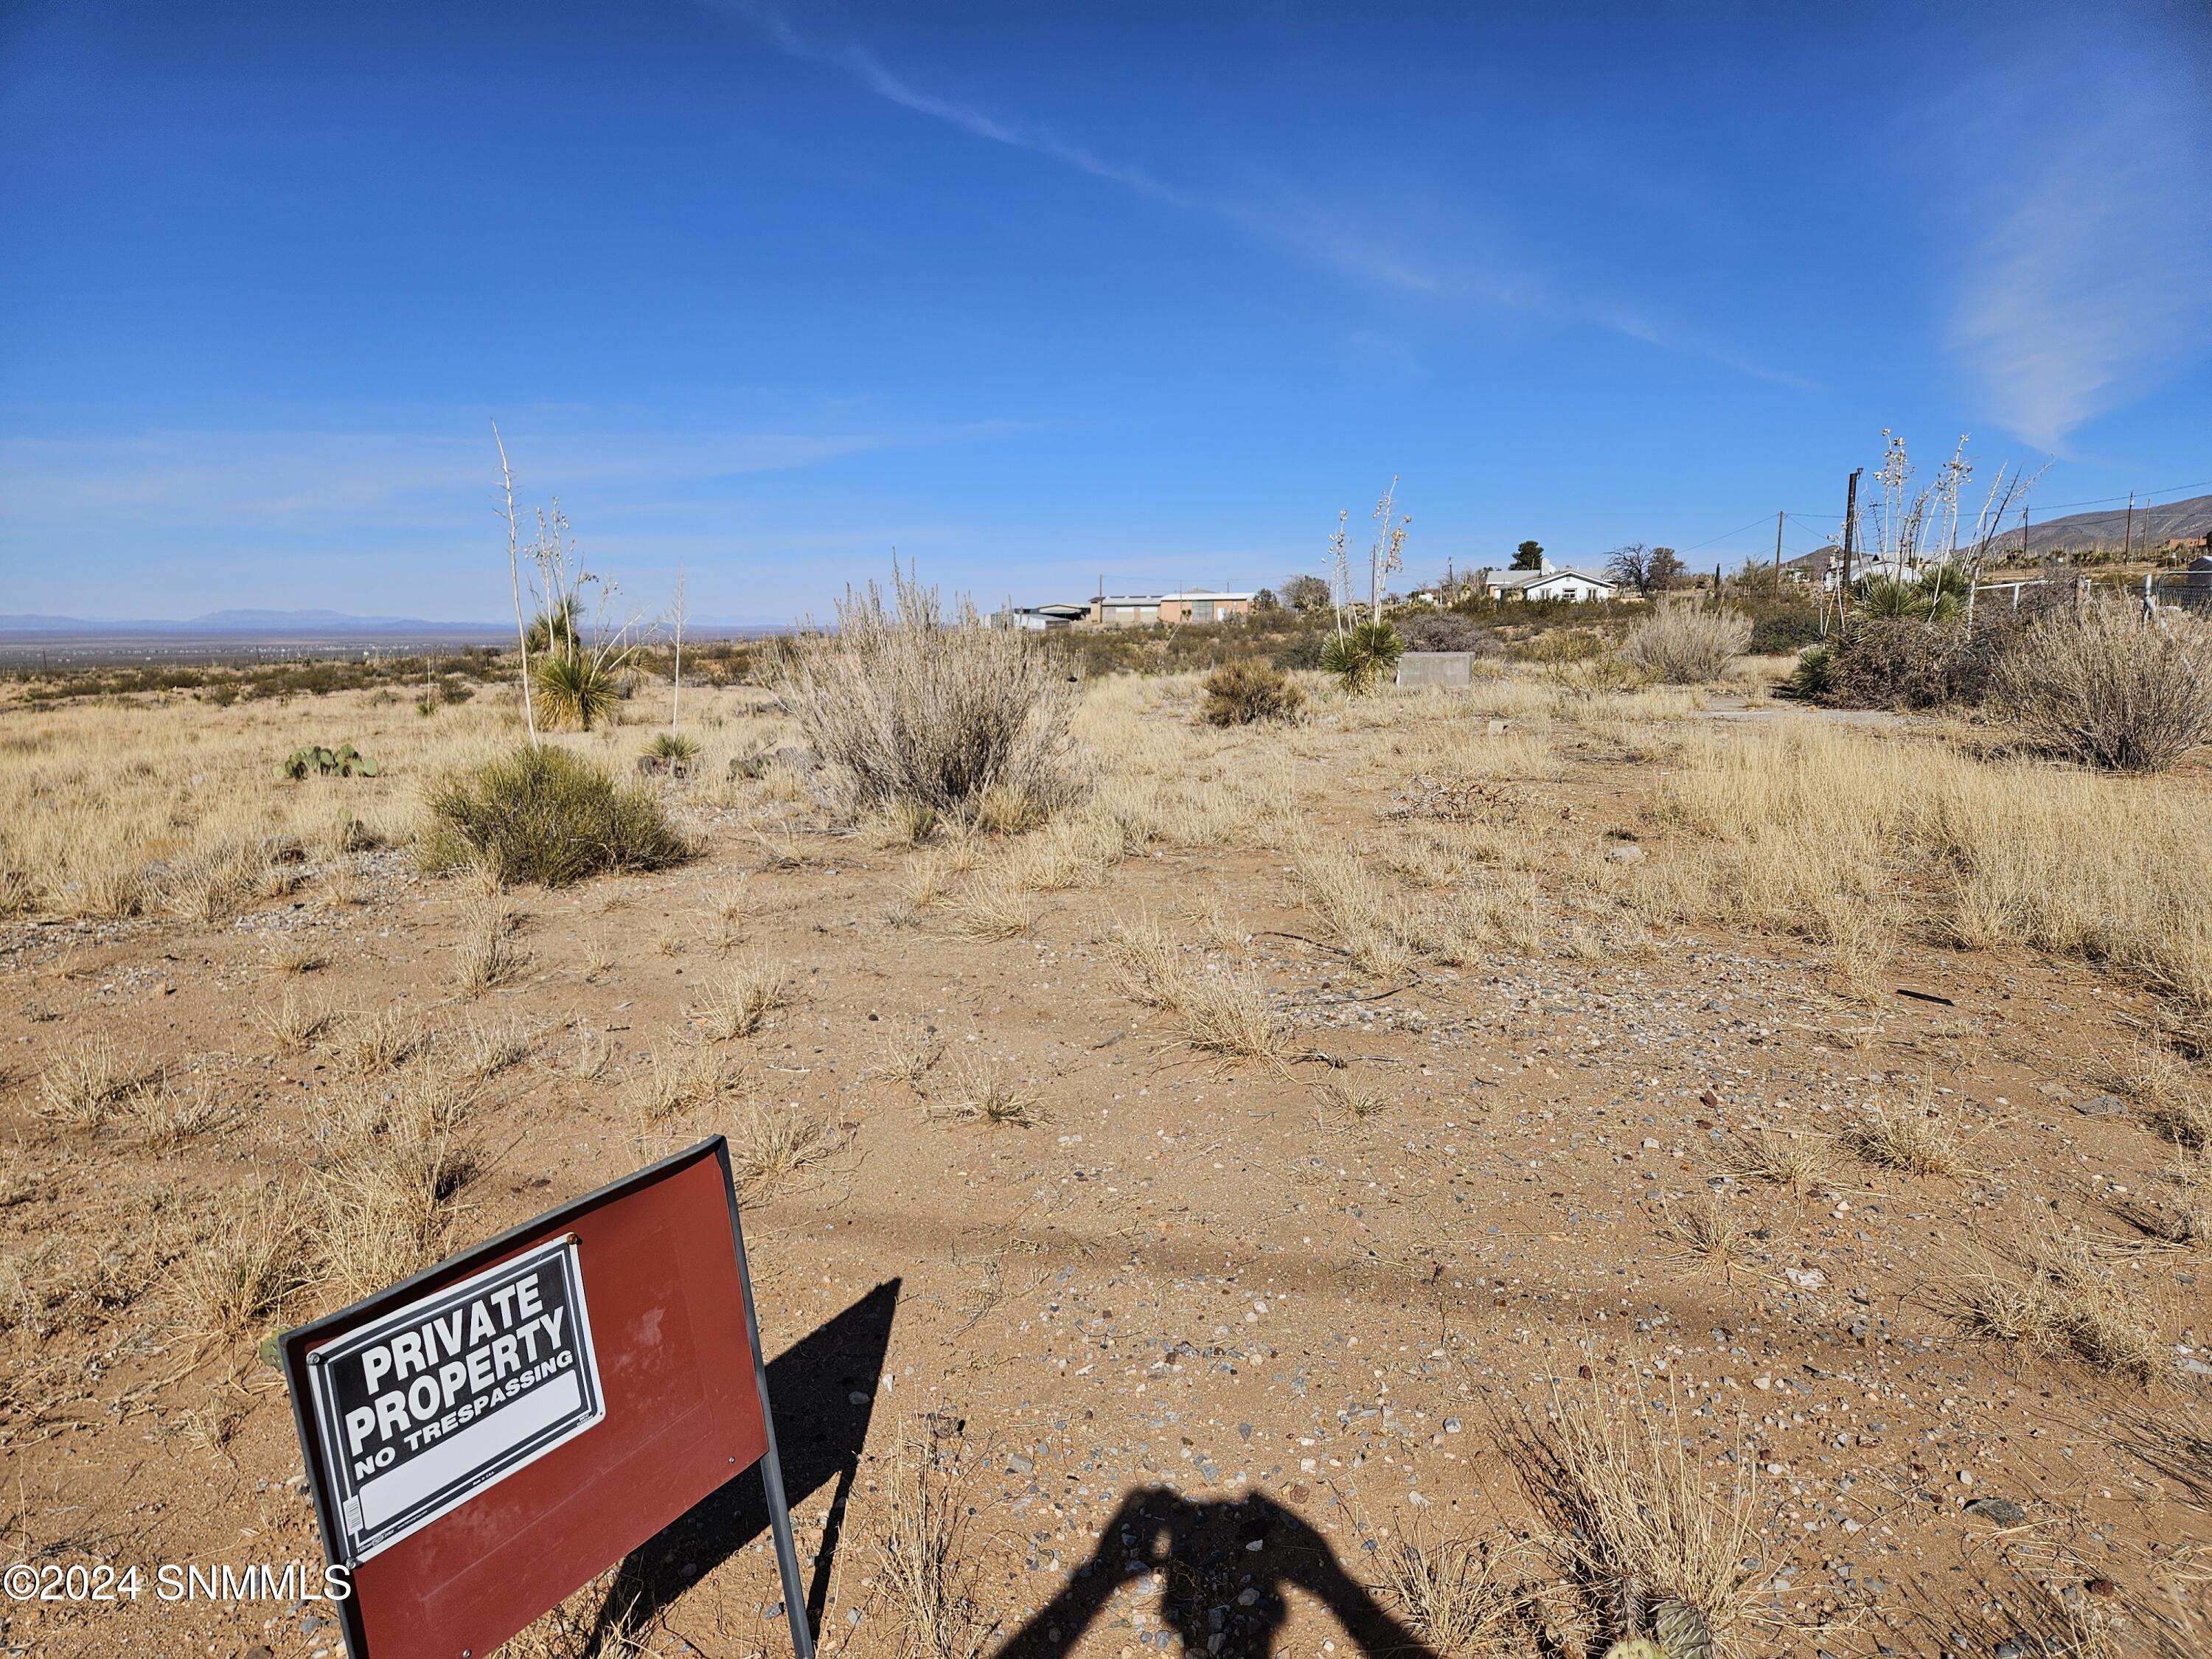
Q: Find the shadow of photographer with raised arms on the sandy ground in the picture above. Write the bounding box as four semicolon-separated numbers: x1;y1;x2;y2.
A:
995;1486;1436;1659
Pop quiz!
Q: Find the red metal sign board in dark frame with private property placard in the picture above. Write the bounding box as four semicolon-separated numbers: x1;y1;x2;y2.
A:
283;1135;812;1659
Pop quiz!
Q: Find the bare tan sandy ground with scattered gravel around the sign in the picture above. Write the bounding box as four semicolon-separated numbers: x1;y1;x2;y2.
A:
0;686;2212;1659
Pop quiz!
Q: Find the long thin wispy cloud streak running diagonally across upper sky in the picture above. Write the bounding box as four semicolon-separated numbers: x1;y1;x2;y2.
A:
726;0;1809;387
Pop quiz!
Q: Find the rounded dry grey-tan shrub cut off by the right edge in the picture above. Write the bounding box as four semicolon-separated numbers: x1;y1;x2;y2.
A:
1991;599;2212;772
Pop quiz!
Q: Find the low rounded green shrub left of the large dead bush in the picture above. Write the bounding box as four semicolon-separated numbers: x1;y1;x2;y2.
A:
420;748;692;887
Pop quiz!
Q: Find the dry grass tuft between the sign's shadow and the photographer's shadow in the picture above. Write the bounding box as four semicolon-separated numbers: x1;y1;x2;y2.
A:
876;1433;998;1659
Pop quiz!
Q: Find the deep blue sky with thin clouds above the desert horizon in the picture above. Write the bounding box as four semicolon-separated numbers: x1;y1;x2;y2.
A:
0;0;2212;622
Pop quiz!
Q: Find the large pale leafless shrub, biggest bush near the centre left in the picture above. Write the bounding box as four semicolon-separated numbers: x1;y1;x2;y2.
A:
779;571;1079;821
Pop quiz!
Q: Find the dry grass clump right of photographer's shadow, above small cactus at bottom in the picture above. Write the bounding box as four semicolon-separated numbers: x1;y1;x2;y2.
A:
1522;1394;1765;1639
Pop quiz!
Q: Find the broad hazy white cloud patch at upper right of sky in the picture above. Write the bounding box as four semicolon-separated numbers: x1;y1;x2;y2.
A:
1951;44;2212;453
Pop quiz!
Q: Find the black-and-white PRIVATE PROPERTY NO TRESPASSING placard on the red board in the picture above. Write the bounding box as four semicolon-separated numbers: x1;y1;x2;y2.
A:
307;1234;606;1566
